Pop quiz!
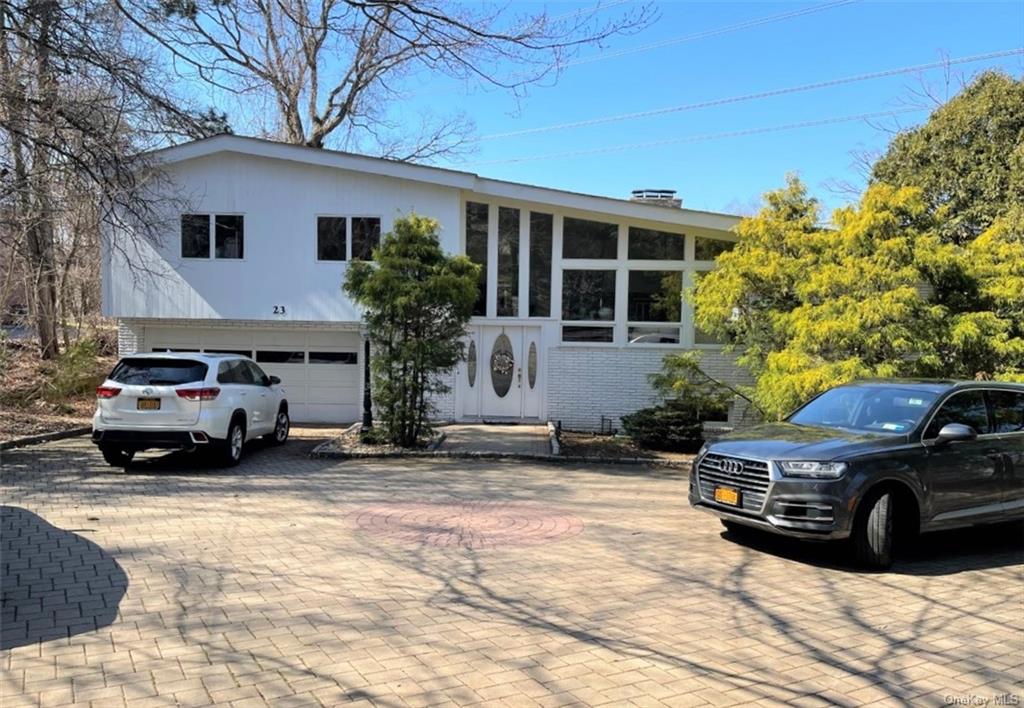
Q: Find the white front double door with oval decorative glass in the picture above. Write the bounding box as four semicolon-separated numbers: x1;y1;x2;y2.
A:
461;325;542;419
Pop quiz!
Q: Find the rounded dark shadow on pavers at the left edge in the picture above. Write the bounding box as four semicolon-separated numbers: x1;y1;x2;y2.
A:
0;506;128;650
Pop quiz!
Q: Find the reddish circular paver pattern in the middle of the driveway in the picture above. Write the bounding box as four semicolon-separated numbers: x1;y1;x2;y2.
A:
353;501;583;550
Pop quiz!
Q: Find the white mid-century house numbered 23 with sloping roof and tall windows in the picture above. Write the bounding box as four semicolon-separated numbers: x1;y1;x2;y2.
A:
103;135;742;429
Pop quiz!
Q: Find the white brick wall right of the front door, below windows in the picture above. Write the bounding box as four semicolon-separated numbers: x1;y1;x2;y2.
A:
548;346;750;430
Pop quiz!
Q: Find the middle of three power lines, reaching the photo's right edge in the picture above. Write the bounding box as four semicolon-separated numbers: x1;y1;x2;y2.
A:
476;48;1024;141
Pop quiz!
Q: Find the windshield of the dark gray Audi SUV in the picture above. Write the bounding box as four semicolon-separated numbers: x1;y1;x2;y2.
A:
788;386;939;434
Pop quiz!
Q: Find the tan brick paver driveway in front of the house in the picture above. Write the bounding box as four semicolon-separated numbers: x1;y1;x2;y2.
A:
0;440;1024;707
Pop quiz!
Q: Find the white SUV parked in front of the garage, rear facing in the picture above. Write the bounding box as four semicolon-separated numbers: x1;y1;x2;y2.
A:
92;352;290;467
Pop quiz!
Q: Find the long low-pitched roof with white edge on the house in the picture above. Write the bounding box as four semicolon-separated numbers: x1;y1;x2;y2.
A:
150;134;740;231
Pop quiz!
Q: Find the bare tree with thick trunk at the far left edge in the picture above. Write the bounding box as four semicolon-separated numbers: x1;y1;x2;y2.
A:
0;0;222;359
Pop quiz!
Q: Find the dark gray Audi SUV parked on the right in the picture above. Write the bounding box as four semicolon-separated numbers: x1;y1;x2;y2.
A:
689;380;1024;568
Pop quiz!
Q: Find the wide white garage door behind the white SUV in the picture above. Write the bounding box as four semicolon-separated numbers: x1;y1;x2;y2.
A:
144;327;361;423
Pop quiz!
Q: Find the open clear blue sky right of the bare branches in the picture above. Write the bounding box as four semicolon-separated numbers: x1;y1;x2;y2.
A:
410;1;1024;212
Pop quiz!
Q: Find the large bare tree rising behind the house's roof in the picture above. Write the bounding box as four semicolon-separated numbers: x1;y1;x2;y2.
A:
115;0;650;160
